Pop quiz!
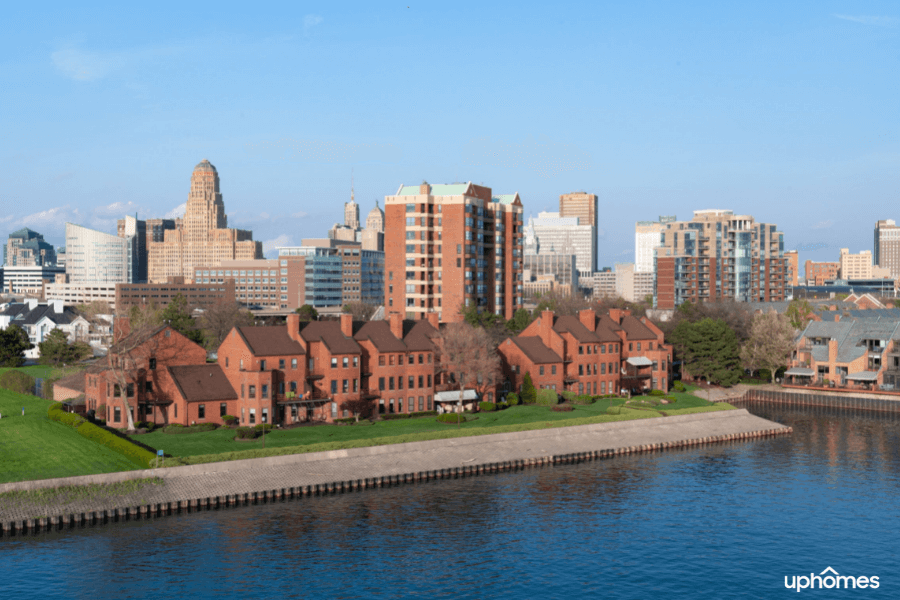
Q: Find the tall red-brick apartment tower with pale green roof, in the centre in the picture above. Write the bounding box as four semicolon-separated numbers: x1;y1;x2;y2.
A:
384;182;522;322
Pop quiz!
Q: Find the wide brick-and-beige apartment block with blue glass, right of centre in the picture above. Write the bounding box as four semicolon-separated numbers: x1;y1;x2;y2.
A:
655;210;788;309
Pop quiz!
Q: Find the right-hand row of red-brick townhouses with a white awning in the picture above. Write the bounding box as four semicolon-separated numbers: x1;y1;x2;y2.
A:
498;309;672;394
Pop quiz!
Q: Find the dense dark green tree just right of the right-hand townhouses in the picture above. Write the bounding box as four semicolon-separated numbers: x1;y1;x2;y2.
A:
672;318;741;387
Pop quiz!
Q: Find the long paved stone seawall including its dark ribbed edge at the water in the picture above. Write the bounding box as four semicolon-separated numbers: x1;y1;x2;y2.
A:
0;409;792;536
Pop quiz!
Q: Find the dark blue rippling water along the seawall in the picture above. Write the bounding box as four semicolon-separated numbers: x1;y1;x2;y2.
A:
0;404;900;599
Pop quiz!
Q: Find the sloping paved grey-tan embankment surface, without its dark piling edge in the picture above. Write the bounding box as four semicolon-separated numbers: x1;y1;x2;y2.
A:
0;409;789;525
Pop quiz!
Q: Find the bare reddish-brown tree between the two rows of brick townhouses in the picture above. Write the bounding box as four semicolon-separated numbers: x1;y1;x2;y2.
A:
434;322;500;425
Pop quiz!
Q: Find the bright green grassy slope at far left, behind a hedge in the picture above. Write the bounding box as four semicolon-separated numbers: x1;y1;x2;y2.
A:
0;389;140;483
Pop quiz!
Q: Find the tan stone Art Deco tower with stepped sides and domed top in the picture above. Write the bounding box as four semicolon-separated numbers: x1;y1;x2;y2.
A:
148;160;263;283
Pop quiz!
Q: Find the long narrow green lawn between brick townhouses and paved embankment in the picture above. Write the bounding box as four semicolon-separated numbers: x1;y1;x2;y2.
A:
142;393;730;457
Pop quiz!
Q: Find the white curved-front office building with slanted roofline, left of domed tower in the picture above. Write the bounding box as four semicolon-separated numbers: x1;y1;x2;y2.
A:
66;223;140;284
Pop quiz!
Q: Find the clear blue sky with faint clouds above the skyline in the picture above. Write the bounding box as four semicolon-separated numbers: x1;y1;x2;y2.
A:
0;0;900;266
